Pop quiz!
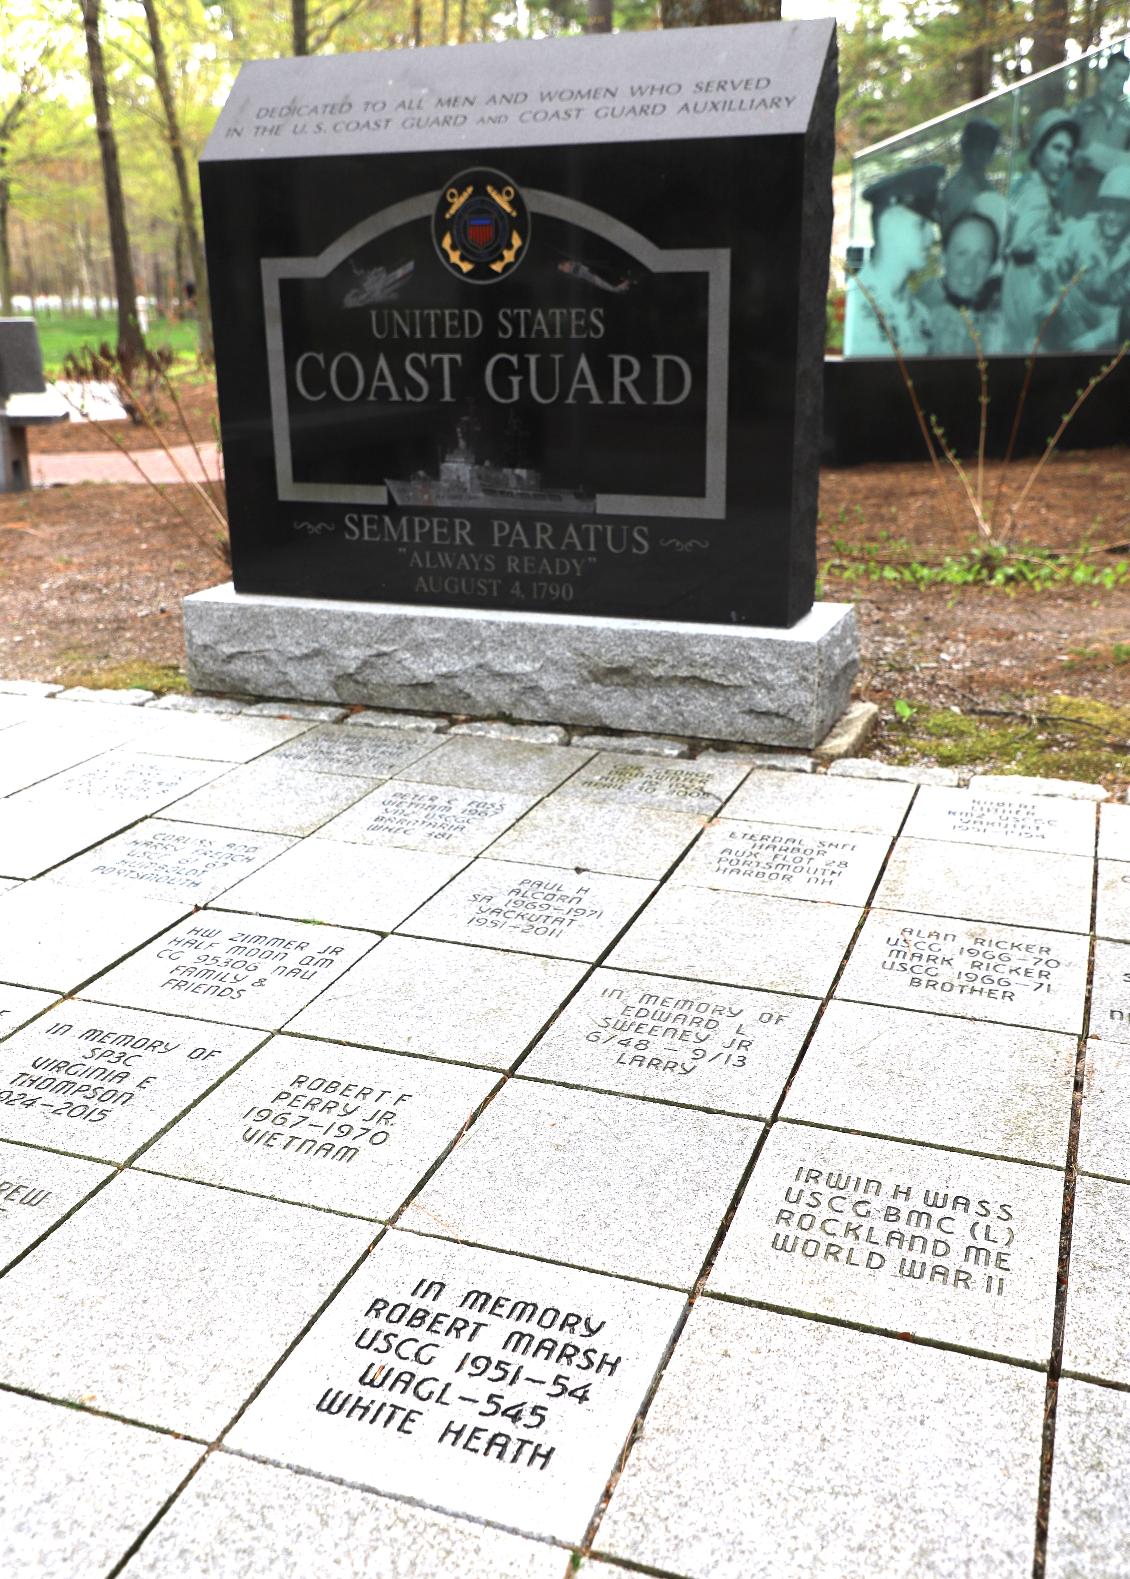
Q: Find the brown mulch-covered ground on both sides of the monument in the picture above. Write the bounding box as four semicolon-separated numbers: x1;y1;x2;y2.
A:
0;374;1130;777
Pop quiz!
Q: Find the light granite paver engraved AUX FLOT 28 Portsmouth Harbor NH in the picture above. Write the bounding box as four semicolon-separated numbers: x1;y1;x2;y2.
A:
671;818;890;905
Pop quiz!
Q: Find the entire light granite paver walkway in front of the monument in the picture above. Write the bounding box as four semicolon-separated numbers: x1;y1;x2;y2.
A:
0;698;1130;1579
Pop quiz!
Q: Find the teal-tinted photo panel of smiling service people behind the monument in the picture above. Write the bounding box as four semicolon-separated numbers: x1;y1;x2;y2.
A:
844;52;1130;357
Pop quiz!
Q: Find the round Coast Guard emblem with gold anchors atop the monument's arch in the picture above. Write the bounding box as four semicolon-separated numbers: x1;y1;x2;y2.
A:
432;169;530;286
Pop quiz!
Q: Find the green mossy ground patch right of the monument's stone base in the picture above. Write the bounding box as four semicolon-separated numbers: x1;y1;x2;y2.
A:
881;696;1130;785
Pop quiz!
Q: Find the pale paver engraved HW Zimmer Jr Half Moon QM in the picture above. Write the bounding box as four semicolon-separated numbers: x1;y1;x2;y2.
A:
87;910;374;1031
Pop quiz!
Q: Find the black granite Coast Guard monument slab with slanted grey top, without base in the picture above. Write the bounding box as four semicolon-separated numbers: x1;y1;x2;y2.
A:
200;22;836;627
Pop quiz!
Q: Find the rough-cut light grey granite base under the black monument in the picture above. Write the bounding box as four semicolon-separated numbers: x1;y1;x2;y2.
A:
185;583;859;747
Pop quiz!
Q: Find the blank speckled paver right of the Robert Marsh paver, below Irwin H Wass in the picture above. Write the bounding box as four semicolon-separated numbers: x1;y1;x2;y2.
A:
597;1300;1045;1579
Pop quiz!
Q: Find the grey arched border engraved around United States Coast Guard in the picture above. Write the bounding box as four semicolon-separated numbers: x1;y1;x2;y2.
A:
262;188;729;521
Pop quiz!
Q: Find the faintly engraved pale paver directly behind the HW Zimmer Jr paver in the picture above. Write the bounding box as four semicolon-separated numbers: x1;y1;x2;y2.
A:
44;818;294;905
